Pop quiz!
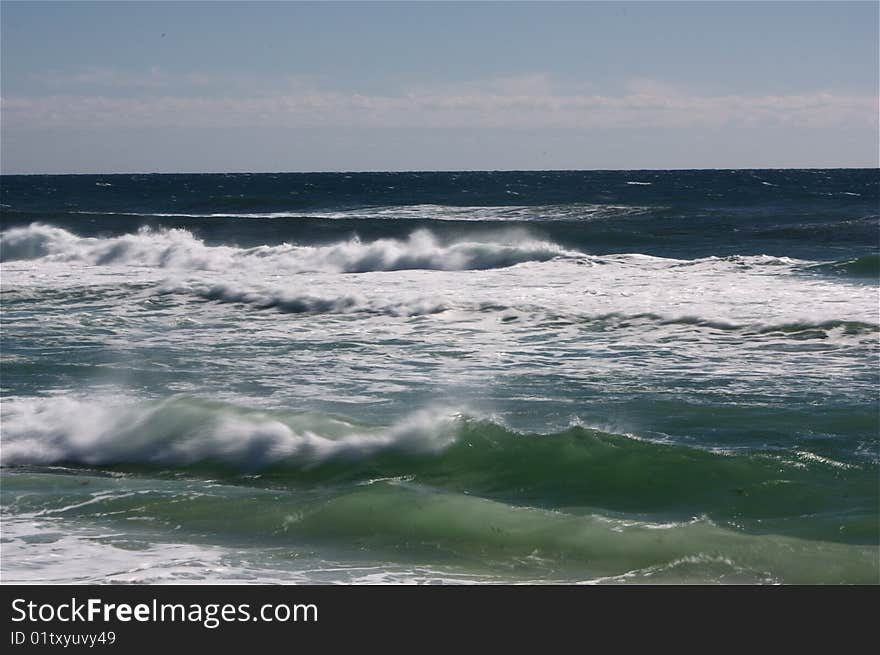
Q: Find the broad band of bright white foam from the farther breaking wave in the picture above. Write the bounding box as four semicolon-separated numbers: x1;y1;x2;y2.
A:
0;225;877;344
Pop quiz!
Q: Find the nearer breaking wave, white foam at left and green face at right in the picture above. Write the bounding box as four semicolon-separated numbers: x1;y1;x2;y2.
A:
0;397;878;527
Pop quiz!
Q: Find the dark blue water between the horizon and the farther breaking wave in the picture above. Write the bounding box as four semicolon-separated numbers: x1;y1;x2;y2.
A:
0;169;880;259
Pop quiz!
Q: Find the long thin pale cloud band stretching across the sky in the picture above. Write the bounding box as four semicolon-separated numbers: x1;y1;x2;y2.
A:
0;78;880;129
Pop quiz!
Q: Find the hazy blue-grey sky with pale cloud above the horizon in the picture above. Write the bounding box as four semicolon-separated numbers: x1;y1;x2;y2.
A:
0;1;880;174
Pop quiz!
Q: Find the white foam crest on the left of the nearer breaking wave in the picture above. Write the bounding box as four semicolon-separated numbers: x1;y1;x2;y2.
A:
0;396;460;470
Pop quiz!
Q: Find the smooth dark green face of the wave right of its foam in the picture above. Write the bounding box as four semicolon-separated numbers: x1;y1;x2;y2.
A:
229;419;878;540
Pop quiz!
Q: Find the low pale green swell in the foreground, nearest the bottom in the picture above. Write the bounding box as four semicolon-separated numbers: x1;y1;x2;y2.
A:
3;473;878;584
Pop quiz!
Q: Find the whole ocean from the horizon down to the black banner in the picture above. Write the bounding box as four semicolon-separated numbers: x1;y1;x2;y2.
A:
0;169;880;584
